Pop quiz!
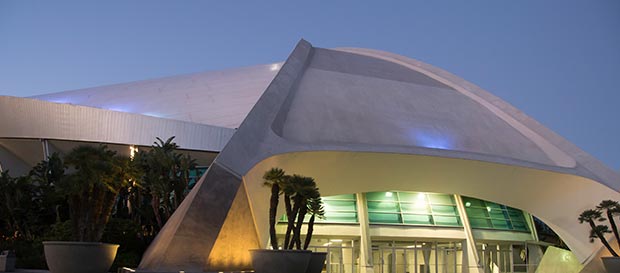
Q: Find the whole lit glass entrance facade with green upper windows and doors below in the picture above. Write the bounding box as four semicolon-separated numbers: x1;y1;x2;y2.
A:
279;191;542;273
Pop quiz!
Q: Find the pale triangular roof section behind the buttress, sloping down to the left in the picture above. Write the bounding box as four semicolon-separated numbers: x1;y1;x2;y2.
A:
33;63;281;128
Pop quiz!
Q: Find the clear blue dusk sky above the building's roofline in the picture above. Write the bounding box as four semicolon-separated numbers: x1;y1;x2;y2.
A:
0;0;620;170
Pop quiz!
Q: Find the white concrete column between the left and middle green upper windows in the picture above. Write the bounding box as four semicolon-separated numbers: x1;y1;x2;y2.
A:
355;193;374;273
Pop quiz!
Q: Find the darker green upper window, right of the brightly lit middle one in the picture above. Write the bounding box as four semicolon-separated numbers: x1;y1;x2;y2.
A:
462;196;529;232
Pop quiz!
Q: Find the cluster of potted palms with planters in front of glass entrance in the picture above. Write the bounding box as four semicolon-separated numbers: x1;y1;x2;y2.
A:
251;168;325;273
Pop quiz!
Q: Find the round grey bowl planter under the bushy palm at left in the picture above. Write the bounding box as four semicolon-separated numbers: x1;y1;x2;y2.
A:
43;241;118;273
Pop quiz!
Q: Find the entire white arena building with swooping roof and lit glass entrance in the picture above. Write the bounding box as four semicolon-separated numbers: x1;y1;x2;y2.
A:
0;40;620;273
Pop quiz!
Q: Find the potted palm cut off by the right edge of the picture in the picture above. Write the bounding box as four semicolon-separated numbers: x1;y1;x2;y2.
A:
578;200;620;272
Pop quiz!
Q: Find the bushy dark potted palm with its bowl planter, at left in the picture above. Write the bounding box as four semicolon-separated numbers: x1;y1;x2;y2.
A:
43;145;134;273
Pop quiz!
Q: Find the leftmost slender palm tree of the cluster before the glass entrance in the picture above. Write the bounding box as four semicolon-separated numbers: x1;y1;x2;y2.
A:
263;168;286;249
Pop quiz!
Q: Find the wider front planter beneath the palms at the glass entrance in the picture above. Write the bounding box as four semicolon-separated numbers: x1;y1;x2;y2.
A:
250;249;312;273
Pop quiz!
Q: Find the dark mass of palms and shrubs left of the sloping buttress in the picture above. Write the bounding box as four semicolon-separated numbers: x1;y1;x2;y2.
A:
0;137;196;269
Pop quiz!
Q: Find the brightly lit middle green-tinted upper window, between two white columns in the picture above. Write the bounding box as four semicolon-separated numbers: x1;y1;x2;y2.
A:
366;192;463;227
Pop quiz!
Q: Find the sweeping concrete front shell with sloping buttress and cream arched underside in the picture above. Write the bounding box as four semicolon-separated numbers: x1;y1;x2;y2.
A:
138;40;620;272
